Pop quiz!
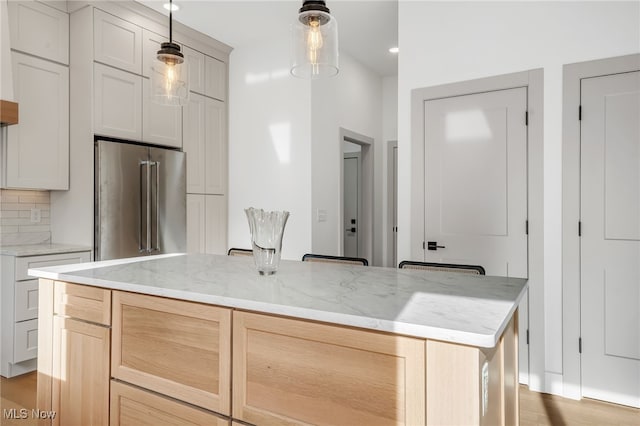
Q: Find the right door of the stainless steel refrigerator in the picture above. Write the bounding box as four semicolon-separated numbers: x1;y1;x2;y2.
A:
149;148;187;254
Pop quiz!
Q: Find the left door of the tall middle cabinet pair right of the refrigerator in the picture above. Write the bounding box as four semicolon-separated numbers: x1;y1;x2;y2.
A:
183;93;207;194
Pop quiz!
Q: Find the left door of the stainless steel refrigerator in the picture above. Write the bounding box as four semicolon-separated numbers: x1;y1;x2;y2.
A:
94;141;149;260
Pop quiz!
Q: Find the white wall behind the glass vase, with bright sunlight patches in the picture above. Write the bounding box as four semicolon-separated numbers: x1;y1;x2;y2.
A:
228;37;311;260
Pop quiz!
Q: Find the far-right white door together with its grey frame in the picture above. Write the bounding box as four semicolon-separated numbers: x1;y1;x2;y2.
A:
563;55;640;407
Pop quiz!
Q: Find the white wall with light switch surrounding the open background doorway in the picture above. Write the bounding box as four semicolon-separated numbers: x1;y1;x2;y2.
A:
311;52;383;265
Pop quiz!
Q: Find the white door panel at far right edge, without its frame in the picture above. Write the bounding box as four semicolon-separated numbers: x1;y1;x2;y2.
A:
580;72;640;407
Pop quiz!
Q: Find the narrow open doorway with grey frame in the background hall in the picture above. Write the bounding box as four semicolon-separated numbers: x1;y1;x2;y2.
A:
339;128;374;265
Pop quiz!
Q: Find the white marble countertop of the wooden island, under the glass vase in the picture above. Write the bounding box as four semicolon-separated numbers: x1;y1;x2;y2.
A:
29;254;527;348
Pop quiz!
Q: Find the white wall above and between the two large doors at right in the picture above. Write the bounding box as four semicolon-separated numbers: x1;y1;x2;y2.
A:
398;0;640;393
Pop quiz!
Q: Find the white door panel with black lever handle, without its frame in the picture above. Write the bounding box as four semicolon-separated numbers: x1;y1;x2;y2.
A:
424;87;529;383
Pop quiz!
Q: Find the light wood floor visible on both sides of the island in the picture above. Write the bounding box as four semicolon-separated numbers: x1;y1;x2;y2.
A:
0;373;640;426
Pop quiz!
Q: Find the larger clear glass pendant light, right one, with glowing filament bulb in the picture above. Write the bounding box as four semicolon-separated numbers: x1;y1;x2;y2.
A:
291;0;338;79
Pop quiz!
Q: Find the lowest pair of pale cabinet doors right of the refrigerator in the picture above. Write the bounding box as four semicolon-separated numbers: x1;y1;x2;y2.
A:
187;194;228;254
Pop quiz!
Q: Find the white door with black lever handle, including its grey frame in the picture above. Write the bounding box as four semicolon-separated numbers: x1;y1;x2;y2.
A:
410;70;545;390
